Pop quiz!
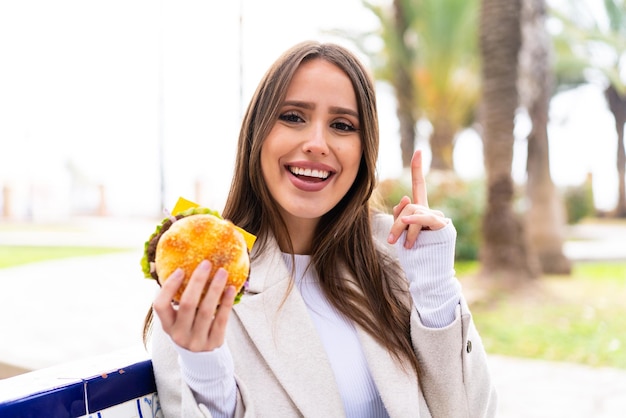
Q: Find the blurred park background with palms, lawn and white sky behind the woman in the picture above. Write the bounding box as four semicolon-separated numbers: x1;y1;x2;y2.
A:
0;0;626;417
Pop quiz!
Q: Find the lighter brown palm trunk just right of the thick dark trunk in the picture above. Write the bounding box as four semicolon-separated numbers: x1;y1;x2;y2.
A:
518;0;572;274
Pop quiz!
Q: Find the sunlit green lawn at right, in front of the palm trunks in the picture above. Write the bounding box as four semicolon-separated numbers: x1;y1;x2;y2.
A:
464;263;626;369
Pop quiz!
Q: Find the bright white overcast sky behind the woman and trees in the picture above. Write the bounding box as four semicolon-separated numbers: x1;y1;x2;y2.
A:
0;0;617;217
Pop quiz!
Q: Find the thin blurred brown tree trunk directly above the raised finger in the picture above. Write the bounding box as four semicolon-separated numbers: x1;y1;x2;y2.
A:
391;0;417;168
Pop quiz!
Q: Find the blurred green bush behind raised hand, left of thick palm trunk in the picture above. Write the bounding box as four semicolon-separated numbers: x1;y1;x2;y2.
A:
378;171;485;260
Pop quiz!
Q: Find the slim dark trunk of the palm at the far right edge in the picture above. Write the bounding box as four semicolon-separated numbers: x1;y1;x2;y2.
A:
605;85;626;218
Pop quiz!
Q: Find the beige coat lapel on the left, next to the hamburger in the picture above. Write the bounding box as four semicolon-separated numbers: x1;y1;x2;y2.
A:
234;241;343;417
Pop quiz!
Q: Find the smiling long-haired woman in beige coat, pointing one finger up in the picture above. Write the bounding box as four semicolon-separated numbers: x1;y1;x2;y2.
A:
146;42;495;418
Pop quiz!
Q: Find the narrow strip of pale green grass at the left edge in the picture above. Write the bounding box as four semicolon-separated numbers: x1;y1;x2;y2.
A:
0;246;128;268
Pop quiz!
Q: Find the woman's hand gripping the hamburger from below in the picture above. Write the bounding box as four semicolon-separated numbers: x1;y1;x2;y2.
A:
152;260;236;352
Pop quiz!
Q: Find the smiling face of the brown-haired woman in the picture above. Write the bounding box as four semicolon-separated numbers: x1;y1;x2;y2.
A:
261;59;362;224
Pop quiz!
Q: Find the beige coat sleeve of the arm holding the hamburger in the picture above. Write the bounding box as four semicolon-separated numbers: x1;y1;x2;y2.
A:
151;315;249;418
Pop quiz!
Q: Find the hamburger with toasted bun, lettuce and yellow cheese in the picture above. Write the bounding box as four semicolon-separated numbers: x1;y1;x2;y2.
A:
141;207;250;302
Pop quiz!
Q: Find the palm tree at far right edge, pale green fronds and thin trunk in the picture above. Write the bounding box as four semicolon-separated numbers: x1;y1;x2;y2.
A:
552;0;626;217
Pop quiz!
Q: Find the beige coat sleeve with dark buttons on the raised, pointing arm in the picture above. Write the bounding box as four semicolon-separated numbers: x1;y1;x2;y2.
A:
411;298;497;417
